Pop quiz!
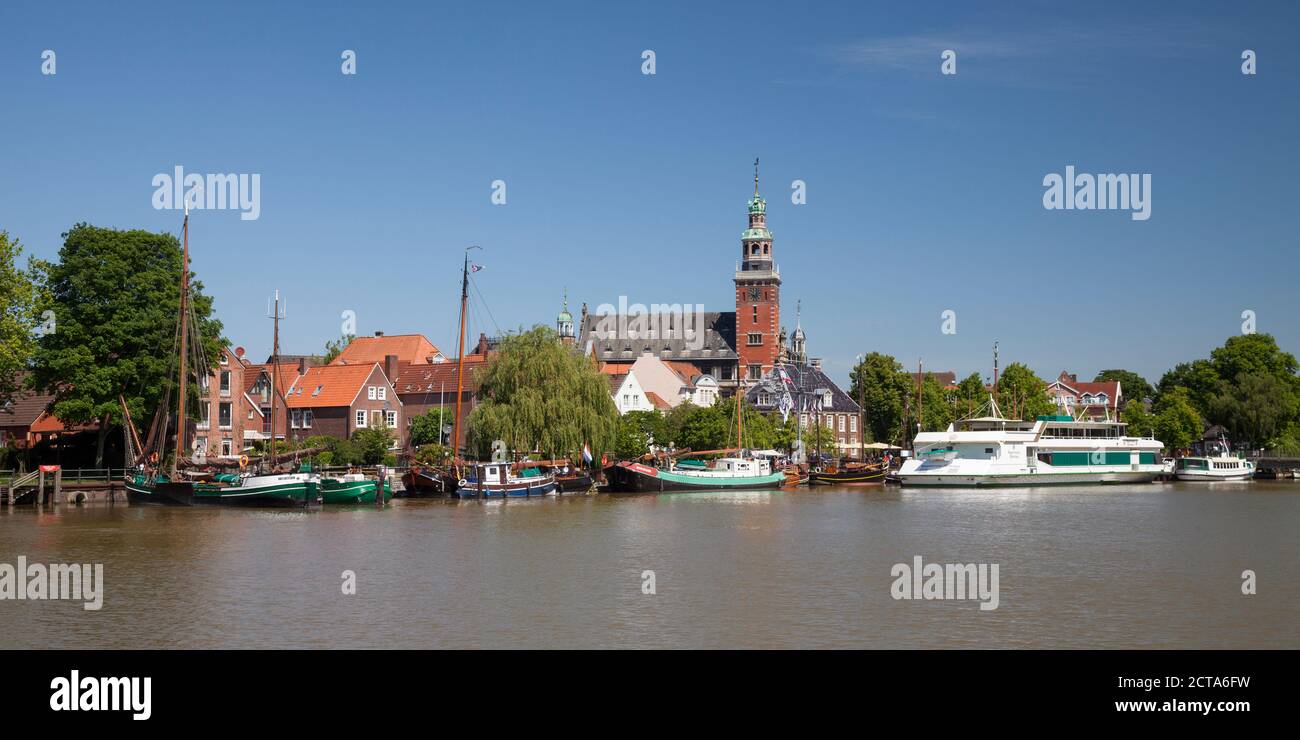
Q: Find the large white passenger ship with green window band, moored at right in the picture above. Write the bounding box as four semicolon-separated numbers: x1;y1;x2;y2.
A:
898;398;1165;486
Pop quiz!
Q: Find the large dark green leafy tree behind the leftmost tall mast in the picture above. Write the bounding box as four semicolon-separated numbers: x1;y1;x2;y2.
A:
33;224;221;467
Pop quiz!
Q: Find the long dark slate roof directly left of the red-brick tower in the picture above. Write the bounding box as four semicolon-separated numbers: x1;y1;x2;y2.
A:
577;311;736;364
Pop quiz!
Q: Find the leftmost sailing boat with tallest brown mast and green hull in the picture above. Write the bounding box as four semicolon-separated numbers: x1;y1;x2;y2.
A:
122;208;320;506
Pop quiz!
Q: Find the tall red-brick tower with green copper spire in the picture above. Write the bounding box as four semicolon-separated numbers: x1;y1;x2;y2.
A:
735;160;781;382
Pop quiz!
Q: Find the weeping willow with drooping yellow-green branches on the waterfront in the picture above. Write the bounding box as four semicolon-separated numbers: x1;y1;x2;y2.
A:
468;326;619;459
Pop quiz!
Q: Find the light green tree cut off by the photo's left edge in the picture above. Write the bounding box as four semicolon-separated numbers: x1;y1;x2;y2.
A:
0;231;40;406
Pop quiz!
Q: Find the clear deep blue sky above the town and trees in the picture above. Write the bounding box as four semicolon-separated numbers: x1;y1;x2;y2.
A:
0;1;1300;381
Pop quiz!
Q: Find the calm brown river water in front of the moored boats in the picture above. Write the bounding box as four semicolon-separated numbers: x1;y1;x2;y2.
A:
0;481;1300;648
